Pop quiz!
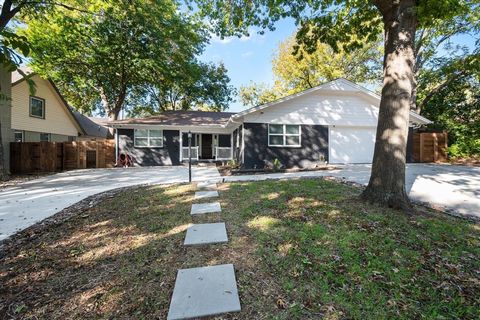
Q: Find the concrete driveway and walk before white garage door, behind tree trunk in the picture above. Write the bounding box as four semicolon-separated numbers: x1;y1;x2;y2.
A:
225;164;480;219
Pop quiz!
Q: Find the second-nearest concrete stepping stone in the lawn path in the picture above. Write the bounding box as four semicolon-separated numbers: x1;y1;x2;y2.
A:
183;222;228;246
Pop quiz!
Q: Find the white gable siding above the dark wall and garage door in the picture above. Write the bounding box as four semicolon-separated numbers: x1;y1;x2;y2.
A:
244;90;378;127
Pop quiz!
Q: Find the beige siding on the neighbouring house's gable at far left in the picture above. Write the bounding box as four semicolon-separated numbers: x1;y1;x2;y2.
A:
12;76;78;136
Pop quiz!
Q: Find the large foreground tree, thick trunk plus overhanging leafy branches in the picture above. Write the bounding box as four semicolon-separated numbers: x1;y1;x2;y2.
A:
192;0;478;210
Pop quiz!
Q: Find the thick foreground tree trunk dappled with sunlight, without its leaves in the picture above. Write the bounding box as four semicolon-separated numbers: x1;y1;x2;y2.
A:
362;0;417;210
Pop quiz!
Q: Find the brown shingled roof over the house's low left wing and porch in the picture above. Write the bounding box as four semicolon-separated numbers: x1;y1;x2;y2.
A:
109;111;235;126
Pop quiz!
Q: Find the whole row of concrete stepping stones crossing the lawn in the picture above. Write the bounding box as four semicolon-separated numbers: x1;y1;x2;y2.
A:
167;181;241;320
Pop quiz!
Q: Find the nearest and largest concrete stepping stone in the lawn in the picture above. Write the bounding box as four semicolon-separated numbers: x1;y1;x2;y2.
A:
167;264;241;320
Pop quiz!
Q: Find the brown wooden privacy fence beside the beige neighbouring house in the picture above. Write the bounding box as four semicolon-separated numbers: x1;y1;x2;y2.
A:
10;140;115;174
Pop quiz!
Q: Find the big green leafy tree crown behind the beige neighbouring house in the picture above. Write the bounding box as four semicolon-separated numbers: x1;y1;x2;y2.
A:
24;0;207;120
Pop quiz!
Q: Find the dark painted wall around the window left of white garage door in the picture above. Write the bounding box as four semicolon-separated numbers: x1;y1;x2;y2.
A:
243;123;328;169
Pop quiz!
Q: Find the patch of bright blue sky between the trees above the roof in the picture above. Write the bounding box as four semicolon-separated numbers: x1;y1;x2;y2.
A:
201;19;296;112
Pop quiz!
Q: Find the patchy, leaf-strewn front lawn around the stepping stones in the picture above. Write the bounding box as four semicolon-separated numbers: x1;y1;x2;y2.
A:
0;179;480;319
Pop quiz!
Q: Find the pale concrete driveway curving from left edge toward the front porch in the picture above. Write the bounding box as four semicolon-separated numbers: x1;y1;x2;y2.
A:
0;166;220;240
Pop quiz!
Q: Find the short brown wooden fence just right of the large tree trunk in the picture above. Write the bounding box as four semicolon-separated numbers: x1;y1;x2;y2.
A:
413;132;447;162
